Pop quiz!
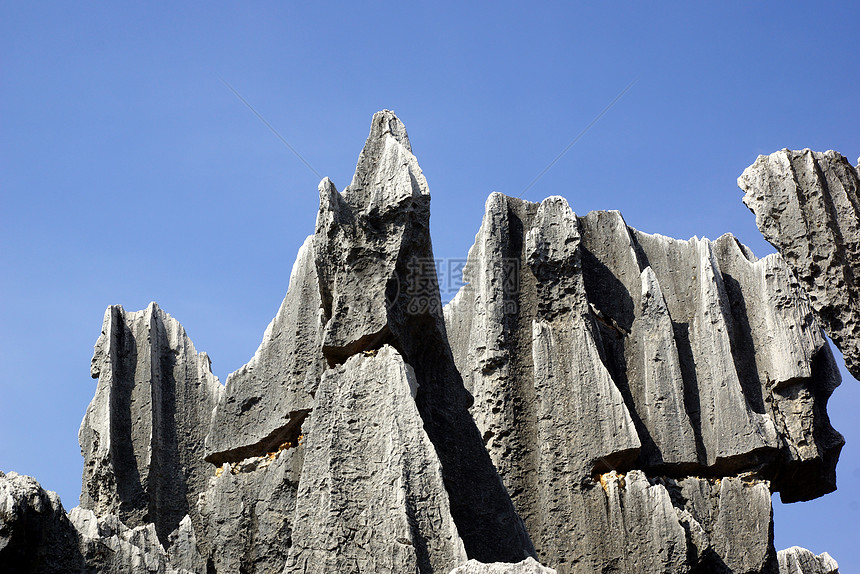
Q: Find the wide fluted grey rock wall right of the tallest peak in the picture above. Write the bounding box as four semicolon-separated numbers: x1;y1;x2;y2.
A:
445;194;843;572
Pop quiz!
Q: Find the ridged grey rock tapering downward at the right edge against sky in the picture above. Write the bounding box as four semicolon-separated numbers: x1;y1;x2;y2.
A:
738;149;860;379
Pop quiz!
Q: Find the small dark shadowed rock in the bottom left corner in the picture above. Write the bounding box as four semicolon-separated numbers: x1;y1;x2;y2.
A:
0;472;85;574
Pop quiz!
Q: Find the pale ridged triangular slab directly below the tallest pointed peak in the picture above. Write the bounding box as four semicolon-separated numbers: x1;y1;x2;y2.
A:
284;346;466;573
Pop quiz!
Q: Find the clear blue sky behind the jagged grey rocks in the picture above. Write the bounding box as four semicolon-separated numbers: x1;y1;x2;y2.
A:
0;1;860;572
